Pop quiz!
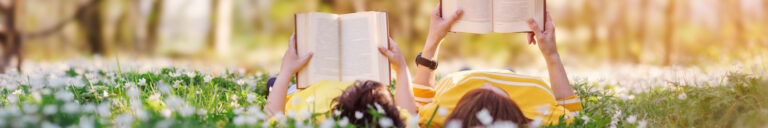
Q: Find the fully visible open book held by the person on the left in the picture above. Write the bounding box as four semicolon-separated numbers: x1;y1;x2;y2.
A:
295;12;390;88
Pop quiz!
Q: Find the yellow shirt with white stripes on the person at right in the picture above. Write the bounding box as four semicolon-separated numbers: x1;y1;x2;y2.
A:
413;70;582;127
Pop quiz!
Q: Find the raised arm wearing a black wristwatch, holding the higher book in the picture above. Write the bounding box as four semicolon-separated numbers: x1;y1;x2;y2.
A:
413;3;464;87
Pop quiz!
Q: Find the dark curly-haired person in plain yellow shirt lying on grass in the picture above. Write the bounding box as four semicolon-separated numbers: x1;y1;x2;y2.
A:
264;35;416;127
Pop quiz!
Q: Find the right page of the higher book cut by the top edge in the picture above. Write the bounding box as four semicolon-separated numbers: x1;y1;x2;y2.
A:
493;0;544;33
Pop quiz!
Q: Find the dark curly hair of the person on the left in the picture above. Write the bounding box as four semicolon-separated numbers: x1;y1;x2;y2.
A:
332;80;405;127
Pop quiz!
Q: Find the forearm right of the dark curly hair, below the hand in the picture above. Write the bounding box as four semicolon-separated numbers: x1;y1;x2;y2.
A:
395;67;417;114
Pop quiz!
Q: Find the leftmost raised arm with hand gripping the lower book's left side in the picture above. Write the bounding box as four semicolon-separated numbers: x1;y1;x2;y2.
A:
264;34;312;117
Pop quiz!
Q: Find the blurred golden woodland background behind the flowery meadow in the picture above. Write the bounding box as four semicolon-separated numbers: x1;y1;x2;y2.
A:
0;0;768;73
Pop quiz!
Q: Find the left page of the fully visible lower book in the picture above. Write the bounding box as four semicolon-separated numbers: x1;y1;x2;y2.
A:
296;13;340;88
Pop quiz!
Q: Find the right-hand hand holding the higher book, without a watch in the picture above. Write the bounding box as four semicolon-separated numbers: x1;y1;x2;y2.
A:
528;11;557;56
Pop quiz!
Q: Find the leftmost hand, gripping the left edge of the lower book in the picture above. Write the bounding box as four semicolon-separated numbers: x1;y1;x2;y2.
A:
280;33;313;75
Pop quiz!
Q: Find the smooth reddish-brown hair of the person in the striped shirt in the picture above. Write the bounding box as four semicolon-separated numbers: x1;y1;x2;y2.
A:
446;89;531;128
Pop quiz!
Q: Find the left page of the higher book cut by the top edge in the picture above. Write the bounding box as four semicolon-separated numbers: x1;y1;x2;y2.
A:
442;0;493;33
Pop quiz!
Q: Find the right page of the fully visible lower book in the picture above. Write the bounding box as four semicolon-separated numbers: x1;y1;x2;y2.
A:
340;12;383;82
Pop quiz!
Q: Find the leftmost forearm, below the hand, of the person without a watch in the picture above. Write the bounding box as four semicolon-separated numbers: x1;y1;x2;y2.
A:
264;73;292;117
